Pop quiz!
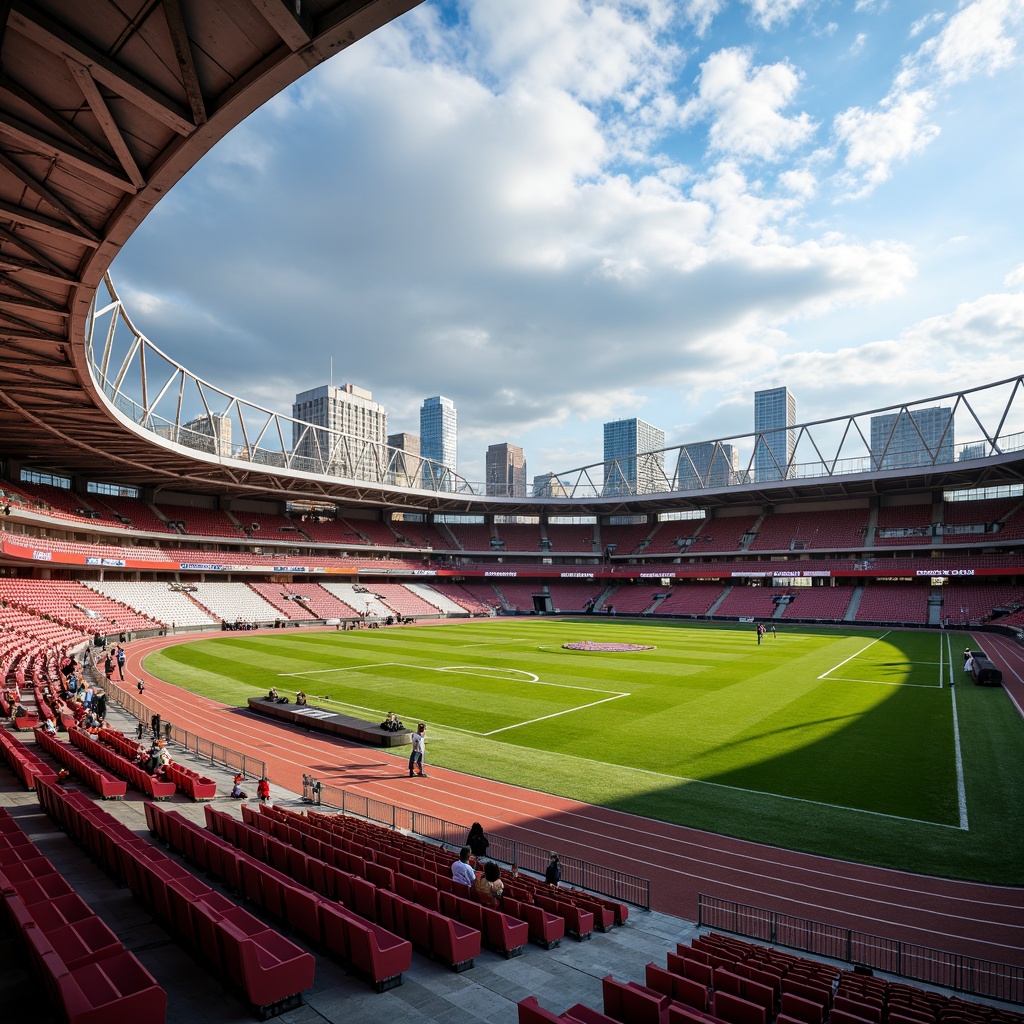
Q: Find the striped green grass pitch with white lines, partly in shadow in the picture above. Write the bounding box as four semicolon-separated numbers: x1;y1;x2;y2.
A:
146;618;1024;885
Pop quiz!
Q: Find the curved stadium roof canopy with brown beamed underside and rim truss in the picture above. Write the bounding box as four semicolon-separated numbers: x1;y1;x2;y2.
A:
0;0;1024;515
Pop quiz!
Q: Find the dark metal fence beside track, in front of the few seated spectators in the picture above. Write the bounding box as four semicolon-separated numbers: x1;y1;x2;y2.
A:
315;776;650;910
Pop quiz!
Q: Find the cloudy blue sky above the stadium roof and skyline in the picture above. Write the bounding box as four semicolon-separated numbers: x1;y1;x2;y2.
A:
114;0;1024;480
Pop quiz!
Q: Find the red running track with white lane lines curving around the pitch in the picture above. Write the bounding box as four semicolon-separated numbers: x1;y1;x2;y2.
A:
121;622;1024;967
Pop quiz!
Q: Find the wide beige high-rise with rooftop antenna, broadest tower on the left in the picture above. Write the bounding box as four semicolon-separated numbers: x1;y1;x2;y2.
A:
292;384;387;480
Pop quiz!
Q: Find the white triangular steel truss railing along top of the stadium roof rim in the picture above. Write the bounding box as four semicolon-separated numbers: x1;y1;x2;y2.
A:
86;274;1024;503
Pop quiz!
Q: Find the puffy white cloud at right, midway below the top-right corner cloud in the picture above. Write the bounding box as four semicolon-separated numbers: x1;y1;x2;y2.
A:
834;89;939;198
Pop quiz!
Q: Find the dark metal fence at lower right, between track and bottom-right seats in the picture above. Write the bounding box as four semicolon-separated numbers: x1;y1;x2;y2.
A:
697;894;1024;1002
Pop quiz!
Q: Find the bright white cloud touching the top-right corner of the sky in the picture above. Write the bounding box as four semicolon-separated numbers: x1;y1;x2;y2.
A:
919;0;1024;85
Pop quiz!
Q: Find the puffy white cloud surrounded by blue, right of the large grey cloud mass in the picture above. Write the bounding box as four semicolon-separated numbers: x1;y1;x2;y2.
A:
682;48;816;161
